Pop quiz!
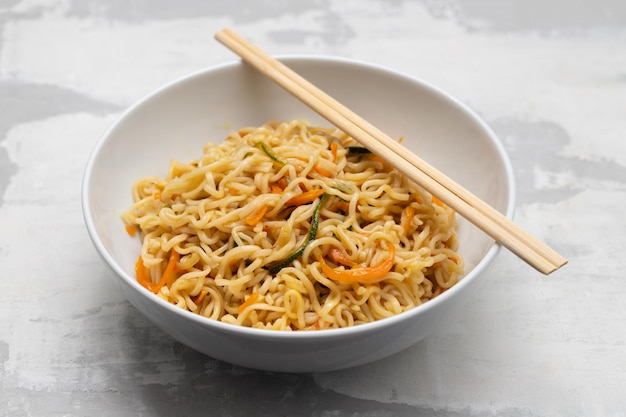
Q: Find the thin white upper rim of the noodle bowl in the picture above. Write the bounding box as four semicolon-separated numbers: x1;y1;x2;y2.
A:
81;54;516;341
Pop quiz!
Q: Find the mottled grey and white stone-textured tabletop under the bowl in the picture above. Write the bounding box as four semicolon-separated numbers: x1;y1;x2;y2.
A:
0;0;626;417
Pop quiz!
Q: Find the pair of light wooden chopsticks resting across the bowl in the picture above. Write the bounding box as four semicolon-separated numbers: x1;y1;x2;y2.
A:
215;28;567;275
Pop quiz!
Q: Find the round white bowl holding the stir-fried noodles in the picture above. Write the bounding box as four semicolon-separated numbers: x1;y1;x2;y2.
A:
82;56;515;372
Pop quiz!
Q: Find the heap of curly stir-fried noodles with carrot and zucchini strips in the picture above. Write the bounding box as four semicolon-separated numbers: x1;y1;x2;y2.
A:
122;120;463;330
